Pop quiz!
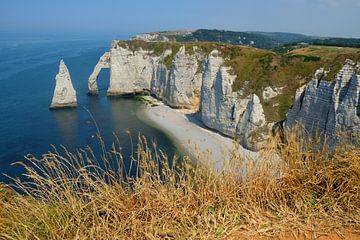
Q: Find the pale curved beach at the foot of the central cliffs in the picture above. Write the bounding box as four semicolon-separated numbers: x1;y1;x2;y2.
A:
138;98;258;169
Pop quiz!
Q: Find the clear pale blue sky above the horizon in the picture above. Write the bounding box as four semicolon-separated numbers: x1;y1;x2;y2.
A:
0;0;360;38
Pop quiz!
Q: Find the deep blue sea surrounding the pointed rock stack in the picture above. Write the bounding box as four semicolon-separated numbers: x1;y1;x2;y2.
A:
0;41;177;182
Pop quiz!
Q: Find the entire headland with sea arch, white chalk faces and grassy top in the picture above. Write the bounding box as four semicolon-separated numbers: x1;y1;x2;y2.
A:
89;40;360;150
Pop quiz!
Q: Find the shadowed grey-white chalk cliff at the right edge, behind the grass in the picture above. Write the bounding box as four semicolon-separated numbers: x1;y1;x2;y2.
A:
285;60;360;146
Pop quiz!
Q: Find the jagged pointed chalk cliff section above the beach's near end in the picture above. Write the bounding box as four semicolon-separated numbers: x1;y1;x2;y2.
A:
201;50;269;150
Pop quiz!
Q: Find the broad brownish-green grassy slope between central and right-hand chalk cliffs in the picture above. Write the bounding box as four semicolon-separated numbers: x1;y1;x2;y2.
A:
227;46;360;122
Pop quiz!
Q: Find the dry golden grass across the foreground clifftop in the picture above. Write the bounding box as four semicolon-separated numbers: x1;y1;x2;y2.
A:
0;131;360;239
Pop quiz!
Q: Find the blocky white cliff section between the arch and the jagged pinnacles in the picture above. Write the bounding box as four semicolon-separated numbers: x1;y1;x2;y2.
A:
108;41;203;108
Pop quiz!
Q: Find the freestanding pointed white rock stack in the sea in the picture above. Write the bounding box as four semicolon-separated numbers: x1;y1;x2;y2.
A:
50;59;77;109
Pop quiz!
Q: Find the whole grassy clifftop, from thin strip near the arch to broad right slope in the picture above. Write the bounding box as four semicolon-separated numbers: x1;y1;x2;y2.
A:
114;41;360;122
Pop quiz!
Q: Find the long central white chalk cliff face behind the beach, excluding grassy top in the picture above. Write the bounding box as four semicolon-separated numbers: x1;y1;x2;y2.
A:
97;41;269;150
